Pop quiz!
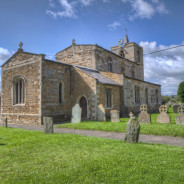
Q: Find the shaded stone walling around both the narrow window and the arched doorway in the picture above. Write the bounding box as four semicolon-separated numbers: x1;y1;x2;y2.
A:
42;61;96;122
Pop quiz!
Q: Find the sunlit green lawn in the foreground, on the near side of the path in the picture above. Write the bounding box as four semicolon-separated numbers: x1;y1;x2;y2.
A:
0;127;184;184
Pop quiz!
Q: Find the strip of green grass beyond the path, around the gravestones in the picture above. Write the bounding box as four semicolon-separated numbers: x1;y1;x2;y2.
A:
57;108;184;137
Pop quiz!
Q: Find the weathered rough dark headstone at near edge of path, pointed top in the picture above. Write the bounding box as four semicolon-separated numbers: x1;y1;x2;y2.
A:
125;114;140;143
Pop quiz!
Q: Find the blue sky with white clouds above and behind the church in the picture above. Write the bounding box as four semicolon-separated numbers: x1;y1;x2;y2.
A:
0;0;184;95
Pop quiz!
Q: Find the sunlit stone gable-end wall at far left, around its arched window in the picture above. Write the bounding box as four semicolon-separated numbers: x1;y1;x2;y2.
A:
1;52;43;125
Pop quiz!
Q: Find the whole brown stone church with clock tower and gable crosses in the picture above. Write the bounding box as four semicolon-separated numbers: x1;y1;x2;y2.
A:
1;35;161;125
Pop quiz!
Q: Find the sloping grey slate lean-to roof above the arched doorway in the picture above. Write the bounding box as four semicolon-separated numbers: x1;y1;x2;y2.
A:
77;66;123;86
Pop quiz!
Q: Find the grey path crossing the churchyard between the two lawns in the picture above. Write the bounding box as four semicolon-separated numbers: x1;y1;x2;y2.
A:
1;124;184;147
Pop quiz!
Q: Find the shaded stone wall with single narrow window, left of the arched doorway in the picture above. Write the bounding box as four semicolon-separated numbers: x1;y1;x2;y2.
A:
42;60;72;122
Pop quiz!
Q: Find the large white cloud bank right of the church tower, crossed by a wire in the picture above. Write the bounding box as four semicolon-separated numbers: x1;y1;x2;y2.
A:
140;42;184;95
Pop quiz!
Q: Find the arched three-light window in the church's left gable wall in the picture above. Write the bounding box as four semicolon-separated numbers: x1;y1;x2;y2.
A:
13;76;25;105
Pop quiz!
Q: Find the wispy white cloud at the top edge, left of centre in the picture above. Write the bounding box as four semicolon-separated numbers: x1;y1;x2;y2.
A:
46;0;77;18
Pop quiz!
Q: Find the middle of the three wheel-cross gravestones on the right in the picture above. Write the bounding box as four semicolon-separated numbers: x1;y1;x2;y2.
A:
157;105;170;123
